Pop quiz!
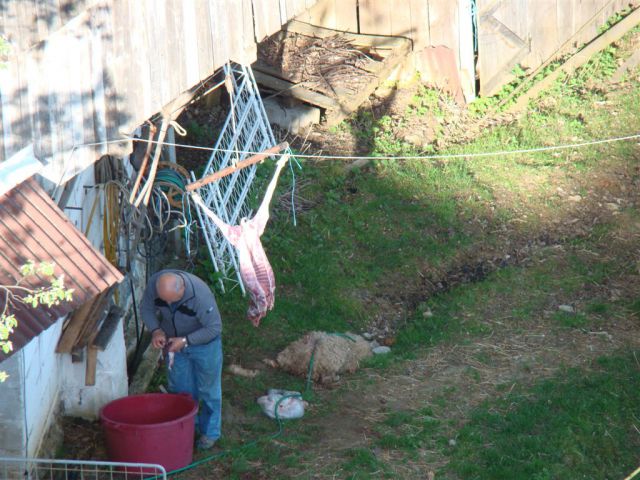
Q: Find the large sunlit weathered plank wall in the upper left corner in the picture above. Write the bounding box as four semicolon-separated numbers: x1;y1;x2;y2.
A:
0;0;315;181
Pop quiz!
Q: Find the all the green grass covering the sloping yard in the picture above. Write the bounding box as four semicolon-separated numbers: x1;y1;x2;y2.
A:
161;27;640;479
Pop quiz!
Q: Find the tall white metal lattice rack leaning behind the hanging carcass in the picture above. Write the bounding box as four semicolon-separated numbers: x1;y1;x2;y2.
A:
191;64;276;293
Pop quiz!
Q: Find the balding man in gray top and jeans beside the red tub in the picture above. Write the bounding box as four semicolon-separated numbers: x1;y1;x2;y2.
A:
141;270;222;450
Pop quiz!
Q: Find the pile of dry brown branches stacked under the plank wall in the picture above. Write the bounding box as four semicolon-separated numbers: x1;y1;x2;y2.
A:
258;32;378;98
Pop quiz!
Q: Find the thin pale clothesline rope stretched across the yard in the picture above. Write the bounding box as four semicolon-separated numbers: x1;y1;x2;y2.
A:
67;133;640;161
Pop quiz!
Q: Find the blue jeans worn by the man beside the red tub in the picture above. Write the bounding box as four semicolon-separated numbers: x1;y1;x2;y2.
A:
169;337;222;440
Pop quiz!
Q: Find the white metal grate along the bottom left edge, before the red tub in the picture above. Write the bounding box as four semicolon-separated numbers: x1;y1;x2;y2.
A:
0;457;167;480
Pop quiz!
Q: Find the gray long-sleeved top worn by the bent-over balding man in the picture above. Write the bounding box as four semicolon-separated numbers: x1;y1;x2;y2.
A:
141;270;222;345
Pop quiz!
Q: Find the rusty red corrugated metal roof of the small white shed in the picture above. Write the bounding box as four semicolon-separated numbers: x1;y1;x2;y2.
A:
0;179;122;361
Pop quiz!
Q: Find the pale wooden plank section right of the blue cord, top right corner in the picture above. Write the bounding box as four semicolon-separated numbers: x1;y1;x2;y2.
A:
478;0;638;95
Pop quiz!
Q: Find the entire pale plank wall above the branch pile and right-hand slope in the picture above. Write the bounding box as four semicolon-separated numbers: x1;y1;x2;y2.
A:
297;0;638;99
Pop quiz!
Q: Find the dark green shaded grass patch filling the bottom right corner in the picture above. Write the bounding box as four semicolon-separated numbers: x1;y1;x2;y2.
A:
449;355;640;480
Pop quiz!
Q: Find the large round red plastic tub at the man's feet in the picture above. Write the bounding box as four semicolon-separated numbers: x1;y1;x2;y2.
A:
100;393;198;471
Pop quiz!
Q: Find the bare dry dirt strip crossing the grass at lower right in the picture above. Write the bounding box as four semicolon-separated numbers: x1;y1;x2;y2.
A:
292;292;640;478
